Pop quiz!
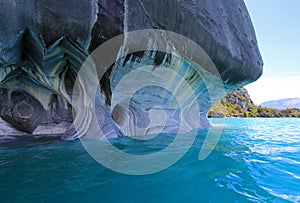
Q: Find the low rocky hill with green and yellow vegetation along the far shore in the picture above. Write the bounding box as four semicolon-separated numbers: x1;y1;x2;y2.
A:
208;88;300;118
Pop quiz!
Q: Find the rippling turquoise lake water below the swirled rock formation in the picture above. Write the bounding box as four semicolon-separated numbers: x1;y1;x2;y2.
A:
0;118;300;203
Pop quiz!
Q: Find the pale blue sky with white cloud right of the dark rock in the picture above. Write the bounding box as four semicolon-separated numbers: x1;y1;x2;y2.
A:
244;0;300;104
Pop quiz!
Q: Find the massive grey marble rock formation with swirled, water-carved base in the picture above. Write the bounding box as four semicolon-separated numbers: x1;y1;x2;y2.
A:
0;0;263;139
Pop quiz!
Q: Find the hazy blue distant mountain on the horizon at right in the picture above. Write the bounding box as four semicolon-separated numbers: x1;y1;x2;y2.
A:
260;98;300;110
